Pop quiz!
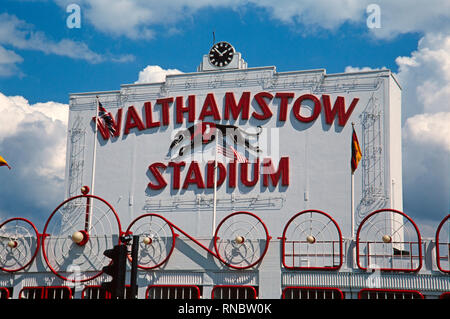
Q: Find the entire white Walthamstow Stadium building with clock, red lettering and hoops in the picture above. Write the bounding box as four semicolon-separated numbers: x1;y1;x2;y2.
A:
0;42;450;299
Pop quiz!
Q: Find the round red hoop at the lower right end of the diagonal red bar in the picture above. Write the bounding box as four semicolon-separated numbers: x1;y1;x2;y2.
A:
214;212;270;269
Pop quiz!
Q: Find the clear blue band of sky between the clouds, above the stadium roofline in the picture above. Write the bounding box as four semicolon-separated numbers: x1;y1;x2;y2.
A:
0;0;420;103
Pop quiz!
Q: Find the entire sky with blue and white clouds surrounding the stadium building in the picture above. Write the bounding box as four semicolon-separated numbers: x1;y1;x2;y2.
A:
0;0;450;234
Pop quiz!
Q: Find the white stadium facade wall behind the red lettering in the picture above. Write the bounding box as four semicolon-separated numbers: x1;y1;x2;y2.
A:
66;67;402;242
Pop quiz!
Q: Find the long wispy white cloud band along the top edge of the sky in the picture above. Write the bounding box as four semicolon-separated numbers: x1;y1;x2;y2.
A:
54;0;450;39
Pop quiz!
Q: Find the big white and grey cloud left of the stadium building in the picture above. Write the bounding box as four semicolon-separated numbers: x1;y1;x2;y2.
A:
0;93;68;228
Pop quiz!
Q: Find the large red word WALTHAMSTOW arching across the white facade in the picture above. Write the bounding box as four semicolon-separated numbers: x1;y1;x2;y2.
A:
113;92;359;140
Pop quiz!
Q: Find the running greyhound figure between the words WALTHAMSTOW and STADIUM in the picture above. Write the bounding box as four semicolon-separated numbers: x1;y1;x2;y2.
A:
166;122;262;158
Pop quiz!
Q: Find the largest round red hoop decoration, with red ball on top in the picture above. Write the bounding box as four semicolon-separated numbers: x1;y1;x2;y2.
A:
42;187;122;282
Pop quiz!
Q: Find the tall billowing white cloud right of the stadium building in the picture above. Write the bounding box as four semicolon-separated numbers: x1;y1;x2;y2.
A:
396;33;450;225
